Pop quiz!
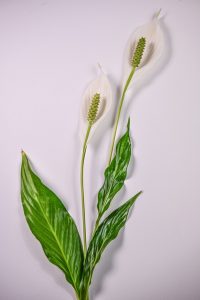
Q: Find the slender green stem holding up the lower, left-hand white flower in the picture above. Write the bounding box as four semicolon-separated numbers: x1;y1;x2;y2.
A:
80;123;92;255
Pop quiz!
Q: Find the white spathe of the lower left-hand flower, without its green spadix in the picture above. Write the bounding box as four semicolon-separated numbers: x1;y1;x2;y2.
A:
80;69;113;142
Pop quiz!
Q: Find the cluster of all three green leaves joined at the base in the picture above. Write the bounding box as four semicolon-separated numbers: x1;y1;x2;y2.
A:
21;120;141;300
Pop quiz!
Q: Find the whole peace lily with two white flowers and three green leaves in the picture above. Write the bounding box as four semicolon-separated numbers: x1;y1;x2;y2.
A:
21;12;164;300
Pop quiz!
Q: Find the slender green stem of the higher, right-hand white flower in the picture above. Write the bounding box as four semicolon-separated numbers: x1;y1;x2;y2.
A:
108;67;135;165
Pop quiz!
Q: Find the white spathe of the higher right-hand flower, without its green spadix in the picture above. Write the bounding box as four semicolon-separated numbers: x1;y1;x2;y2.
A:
123;13;165;86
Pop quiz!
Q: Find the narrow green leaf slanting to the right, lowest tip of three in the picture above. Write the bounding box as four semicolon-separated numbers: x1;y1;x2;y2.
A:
82;192;141;291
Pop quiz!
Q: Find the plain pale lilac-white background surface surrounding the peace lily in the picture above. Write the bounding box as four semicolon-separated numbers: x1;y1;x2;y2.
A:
0;0;200;300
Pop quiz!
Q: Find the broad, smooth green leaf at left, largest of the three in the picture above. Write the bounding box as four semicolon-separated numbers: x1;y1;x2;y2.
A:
21;153;84;294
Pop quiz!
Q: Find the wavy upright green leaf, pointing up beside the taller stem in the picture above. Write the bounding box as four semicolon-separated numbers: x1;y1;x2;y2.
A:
97;119;131;220
